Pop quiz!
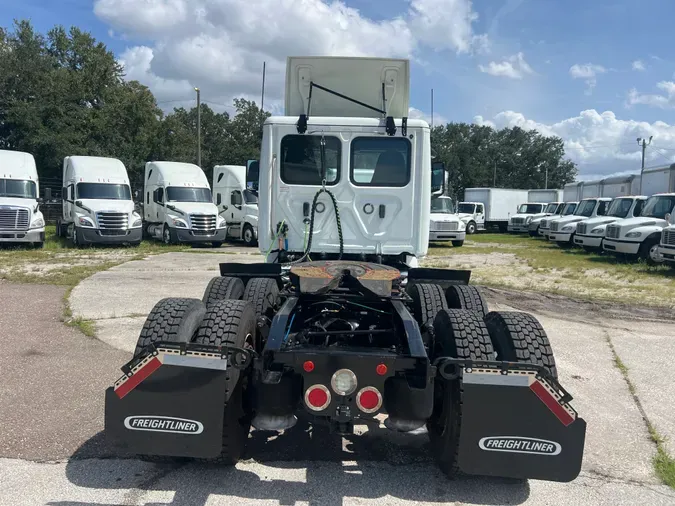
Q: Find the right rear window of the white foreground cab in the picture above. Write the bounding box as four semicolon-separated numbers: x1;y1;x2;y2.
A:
349;137;412;187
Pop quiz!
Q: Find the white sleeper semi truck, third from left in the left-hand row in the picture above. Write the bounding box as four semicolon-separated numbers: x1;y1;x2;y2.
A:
143;162;227;248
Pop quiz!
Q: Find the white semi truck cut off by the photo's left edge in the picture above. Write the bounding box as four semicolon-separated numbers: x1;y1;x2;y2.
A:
0;150;45;248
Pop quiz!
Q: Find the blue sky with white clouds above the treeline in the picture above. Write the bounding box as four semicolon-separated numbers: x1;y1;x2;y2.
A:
0;0;675;177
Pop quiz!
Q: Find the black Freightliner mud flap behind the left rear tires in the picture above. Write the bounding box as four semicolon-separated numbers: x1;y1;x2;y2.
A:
105;348;244;458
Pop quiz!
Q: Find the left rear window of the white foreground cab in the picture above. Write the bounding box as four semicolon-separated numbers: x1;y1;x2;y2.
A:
280;135;342;186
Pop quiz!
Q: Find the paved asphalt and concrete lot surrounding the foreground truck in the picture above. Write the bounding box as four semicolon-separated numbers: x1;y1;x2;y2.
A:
0;253;675;506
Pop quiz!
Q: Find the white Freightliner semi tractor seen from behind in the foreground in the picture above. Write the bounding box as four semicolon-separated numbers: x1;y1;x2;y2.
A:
105;58;586;482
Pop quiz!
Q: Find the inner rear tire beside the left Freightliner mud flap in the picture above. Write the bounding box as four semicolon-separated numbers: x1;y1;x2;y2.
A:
195;300;256;465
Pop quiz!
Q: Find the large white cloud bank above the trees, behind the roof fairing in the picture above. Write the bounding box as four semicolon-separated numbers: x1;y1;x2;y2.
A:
94;0;487;110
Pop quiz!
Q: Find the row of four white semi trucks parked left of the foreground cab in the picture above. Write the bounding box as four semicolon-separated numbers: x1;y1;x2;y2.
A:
0;150;258;247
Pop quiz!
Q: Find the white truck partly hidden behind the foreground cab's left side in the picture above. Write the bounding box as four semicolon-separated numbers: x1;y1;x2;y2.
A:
213;165;258;246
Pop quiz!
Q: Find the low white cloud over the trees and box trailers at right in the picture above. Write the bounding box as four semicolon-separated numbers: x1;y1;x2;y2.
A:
474;109;675;177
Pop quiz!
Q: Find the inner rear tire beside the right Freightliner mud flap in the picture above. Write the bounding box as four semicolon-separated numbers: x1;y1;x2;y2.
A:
427;309;494;477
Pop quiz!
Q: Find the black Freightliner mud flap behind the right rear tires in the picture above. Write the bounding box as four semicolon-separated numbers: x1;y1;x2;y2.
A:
458;369;586;482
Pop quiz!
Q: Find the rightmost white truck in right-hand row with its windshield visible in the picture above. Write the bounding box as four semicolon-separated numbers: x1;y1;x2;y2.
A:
602;193;675;263
